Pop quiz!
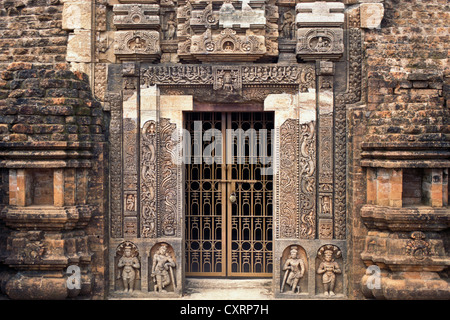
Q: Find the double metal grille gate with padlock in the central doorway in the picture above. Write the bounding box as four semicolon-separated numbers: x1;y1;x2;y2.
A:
185;112;274;277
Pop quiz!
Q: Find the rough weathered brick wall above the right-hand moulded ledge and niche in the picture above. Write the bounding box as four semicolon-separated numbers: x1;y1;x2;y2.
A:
364;0;450;142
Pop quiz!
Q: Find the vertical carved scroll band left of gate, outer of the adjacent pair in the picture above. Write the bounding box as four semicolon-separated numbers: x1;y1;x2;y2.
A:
141;121;157;238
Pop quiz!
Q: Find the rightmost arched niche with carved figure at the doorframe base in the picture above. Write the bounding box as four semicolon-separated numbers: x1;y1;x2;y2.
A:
315;244;343;297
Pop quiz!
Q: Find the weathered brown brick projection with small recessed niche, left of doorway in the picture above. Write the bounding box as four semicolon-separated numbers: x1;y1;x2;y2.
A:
0;62;107;299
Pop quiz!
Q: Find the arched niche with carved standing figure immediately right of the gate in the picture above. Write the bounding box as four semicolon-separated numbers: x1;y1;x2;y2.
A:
280;245;308;294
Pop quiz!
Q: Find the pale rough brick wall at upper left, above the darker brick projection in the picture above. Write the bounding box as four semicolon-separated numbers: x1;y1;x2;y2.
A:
0;0;67;70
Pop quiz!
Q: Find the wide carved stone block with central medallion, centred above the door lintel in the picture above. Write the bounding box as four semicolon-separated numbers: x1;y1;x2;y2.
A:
177;0;278;62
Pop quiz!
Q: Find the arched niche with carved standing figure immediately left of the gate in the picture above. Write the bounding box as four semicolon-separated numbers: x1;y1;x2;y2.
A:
148;242;178;293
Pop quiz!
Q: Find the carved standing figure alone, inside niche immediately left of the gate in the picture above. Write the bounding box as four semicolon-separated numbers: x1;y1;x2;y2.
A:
151;244;176;292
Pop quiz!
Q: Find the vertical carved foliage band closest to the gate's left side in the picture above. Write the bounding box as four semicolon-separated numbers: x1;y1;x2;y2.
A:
159;118;178;236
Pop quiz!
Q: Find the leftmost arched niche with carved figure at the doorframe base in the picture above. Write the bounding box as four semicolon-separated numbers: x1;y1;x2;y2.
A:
114;241;141;293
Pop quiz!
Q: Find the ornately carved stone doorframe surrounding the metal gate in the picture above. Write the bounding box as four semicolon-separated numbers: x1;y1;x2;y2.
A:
104;30;358;298
